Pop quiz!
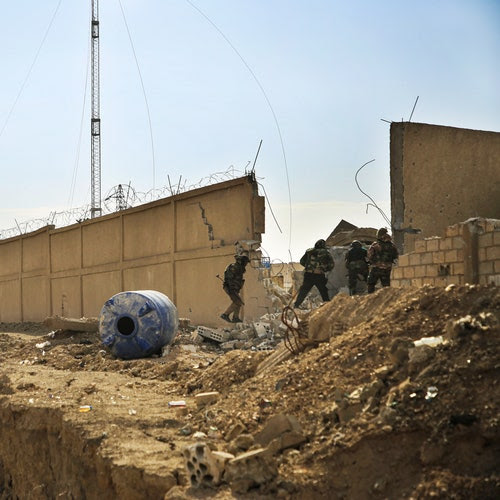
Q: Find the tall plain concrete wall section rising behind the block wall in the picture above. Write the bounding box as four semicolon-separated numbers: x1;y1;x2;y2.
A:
390;122;500;253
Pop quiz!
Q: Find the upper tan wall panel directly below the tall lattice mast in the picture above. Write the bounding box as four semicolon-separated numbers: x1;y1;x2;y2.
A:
82;216;121;268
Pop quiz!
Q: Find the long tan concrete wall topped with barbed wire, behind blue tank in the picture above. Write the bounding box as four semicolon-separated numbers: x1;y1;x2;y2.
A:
0;177;267;326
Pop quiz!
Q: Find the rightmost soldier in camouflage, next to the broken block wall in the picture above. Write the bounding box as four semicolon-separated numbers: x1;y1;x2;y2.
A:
367;227;398;293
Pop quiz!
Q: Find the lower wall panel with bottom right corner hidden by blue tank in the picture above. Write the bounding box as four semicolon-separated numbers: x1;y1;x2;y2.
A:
82;271;122;318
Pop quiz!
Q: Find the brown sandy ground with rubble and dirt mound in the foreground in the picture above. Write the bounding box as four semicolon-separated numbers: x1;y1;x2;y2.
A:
0;286;500;499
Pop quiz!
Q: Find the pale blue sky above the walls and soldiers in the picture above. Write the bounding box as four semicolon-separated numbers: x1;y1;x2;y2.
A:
0;0;500;260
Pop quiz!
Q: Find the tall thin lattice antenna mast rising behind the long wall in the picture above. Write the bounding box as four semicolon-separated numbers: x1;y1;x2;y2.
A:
90;0;102;218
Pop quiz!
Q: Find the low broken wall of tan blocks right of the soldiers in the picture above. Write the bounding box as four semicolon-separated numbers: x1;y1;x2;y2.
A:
391;219;500;287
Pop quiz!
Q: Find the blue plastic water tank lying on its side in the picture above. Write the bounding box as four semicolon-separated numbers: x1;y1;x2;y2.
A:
99;290;179;359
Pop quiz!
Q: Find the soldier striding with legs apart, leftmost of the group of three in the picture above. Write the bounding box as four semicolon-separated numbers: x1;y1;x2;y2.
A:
294;240;334;307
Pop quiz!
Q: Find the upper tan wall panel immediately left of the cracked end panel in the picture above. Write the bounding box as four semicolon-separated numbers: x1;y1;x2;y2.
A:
123;203;174;260
